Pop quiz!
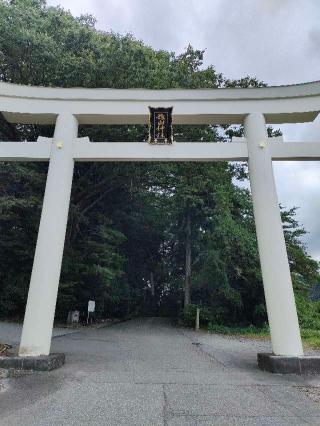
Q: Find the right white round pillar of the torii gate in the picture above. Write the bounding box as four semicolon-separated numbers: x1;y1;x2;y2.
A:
244;113;303;359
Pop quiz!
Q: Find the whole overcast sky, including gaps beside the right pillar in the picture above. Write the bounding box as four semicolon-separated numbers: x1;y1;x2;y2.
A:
47;0;320;260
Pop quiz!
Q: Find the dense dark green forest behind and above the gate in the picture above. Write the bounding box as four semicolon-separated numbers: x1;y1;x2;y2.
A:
0;0;319;325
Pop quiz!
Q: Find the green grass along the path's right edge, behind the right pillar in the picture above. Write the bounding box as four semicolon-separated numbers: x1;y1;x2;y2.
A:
208;323;320;350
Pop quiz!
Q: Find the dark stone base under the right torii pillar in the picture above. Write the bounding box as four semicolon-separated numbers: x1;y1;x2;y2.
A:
258;353;320;375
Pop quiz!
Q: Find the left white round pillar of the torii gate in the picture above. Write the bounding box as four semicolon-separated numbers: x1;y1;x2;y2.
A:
19;113;78;357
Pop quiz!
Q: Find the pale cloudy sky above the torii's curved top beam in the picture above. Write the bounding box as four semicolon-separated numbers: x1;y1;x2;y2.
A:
49;0;320;84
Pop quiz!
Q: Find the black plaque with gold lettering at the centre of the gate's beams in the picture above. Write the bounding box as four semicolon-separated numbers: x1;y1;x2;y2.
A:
149;107;173;145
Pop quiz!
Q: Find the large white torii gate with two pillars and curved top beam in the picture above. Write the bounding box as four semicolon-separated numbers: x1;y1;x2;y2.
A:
0;82;320;357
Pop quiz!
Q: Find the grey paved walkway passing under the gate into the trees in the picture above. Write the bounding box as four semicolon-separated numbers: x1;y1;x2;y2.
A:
0;318;320;426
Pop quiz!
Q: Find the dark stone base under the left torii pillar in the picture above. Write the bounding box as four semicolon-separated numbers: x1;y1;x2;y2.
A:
0;354;65;371
